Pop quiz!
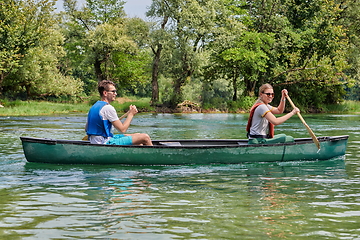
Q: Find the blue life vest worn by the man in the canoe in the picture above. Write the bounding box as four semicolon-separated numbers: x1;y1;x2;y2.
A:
86;101;113;138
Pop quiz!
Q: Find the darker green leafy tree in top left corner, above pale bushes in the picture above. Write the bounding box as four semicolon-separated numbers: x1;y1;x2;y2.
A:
0;0;55;90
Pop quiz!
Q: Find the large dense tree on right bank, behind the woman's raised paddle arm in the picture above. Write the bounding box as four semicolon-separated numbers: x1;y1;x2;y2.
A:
259;1;348;105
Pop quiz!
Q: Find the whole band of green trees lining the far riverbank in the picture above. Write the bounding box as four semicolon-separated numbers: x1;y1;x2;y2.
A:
0;0;360;112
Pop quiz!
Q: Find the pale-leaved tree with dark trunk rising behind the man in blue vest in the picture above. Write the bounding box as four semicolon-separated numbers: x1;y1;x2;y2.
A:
64;0;131;81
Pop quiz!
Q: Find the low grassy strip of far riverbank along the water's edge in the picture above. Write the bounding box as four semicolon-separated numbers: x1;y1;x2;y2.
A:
0;98;360;116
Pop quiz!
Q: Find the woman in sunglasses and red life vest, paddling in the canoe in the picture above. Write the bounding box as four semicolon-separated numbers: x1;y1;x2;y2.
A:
246;84;300;144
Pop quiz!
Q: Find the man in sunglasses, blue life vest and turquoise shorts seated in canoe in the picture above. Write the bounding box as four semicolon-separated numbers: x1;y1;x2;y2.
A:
85;80;152;146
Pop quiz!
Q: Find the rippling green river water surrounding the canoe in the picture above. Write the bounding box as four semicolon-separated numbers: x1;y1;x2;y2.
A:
0;114;360;240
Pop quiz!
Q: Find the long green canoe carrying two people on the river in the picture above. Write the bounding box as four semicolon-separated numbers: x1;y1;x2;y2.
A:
21;135;349;165
